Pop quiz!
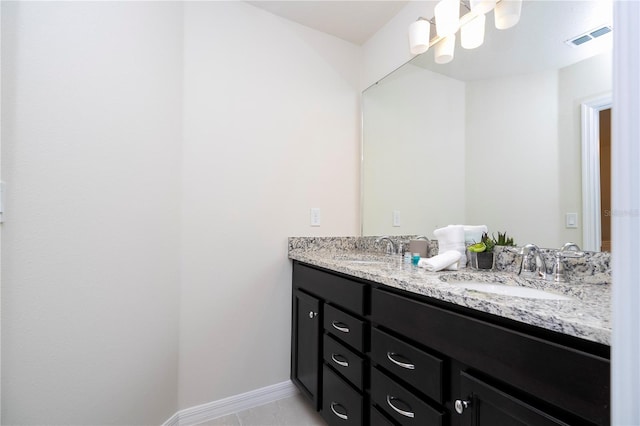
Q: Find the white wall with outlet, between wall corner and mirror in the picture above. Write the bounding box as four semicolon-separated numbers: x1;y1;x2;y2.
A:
180;2;361;408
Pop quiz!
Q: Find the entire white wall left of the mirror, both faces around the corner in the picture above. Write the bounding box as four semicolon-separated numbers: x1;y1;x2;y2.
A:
2;2;361;424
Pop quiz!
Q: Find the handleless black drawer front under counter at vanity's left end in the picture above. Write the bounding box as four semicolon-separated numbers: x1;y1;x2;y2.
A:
293;262;365;315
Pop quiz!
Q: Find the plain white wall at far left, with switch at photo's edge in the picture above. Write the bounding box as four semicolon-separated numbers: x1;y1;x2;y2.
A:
2;2;182;425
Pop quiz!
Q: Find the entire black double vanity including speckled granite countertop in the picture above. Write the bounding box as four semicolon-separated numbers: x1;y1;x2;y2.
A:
289;238;611;426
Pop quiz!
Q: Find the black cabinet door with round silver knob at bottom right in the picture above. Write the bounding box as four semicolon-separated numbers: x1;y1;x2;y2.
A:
454;372;568;426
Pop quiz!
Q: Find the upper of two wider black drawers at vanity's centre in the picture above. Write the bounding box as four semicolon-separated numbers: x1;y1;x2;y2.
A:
371;328;443;403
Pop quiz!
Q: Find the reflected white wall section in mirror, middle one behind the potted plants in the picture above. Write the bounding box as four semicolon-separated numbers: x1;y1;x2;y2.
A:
465;71;561;247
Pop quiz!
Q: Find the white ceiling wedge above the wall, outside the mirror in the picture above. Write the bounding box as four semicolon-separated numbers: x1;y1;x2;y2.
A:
247;0;408;45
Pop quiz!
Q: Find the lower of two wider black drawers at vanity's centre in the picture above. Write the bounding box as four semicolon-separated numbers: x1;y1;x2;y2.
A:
371;368;444;426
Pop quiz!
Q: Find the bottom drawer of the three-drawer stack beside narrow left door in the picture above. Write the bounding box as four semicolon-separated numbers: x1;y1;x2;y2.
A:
321;365;364;426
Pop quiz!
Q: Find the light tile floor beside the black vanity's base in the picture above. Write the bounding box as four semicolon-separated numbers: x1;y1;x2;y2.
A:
198;394;326;426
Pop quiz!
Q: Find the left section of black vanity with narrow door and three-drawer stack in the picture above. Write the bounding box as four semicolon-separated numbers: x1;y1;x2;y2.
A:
291;263;369;426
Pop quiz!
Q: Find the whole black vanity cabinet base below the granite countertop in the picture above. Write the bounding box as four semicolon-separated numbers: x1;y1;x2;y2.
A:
291;262;610;426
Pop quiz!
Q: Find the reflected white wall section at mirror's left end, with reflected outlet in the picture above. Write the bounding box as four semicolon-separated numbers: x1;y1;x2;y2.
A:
363;64;466;237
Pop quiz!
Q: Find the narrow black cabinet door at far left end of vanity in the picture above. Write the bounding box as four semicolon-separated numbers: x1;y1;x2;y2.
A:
291;291;322;410
